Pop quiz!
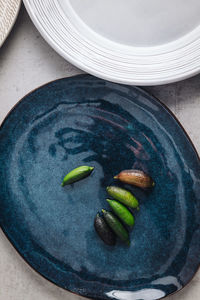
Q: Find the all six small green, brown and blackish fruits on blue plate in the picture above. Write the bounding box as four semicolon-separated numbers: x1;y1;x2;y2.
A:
62;166;155;246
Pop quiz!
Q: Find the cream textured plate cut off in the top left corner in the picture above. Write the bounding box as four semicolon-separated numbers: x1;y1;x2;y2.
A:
0;0;21;47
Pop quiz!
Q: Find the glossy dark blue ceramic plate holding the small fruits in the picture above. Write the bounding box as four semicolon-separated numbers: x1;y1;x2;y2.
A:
0;75;200;300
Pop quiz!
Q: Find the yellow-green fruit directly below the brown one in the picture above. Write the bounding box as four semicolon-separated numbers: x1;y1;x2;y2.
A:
106;186;139;208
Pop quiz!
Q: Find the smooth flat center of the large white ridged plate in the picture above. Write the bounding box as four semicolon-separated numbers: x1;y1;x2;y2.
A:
63;0;200;47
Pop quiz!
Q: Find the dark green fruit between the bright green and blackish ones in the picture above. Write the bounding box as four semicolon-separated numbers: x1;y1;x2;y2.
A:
102;209;130;245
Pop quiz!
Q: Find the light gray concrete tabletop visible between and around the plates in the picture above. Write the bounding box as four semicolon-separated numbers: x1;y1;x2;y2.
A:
0;7;200;300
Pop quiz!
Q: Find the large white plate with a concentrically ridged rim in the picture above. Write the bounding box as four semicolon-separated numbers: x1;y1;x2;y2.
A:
24;0;200;85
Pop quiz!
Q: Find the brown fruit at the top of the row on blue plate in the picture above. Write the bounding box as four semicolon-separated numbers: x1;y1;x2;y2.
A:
114;170;155;189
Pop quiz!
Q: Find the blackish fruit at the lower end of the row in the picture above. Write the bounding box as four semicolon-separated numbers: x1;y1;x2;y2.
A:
94;213;116;246
